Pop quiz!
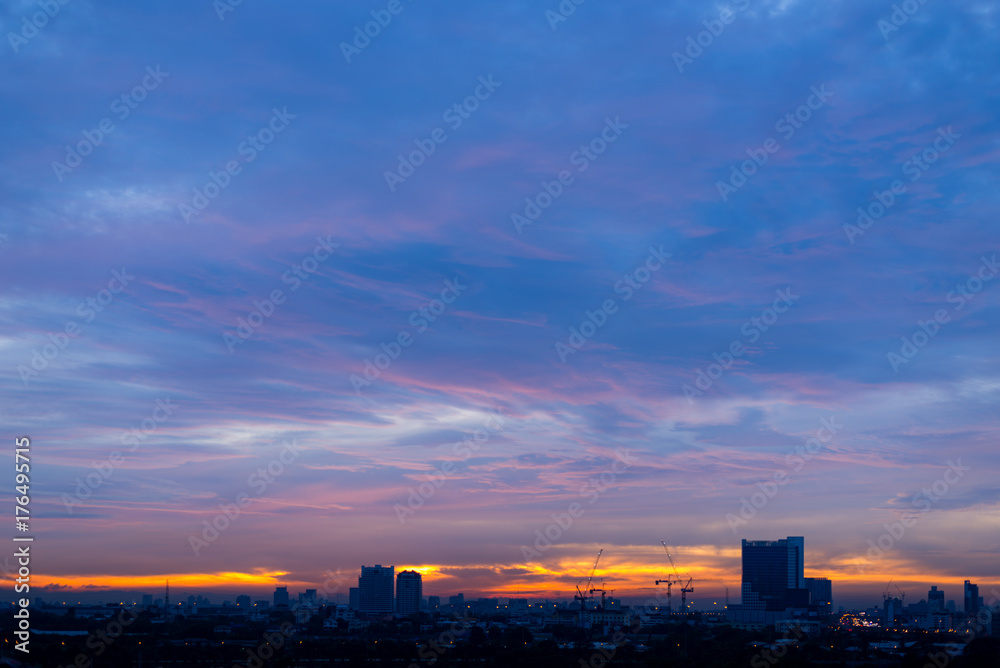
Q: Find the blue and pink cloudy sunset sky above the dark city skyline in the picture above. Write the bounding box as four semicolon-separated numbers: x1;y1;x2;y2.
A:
0;0;1000;608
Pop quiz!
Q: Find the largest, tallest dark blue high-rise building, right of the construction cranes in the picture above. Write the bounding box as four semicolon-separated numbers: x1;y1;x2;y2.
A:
740;536;809;610
